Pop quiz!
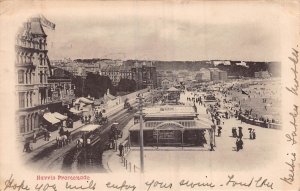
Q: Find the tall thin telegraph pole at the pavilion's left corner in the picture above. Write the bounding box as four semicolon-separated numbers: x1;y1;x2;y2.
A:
137;94;144;173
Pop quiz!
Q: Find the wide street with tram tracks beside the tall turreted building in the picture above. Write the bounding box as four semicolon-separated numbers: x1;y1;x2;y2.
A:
23;103;136;172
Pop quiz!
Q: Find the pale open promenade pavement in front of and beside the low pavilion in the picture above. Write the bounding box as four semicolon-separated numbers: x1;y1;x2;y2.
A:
103;92;282;173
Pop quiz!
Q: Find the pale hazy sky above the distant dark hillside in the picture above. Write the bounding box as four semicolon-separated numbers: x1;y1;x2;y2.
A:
44;2;280;61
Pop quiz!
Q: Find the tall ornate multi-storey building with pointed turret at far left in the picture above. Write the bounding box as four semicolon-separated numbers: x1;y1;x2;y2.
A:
15;17;51;136
